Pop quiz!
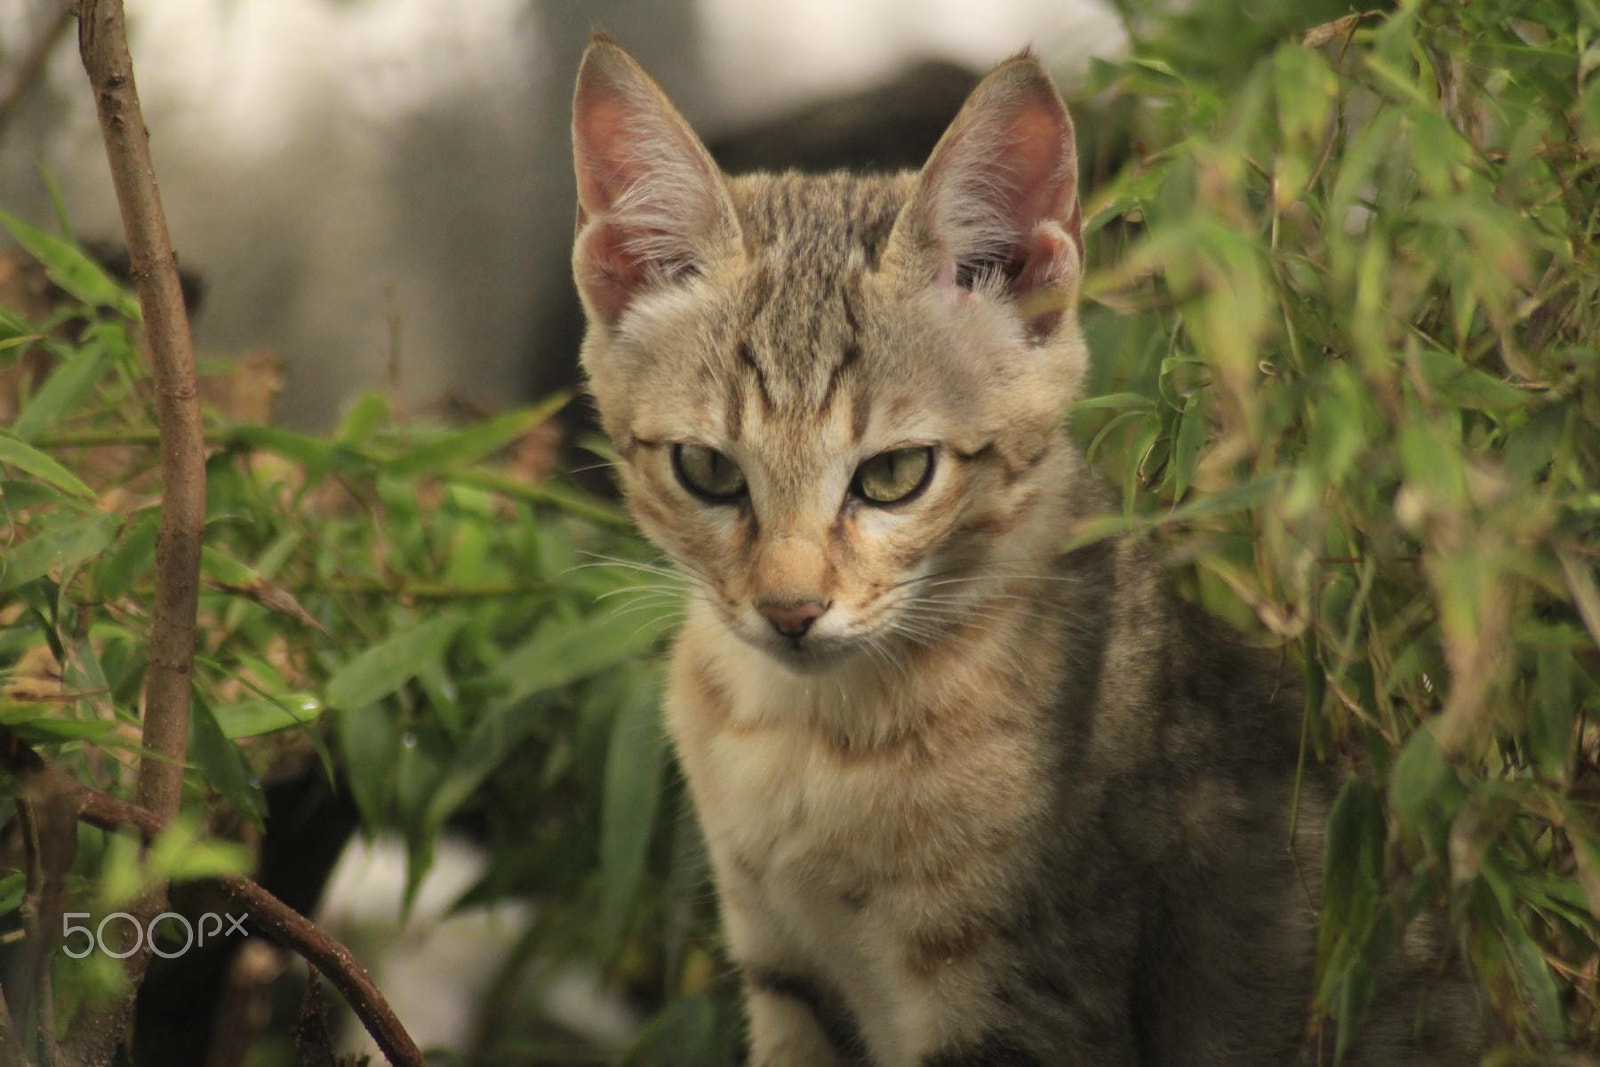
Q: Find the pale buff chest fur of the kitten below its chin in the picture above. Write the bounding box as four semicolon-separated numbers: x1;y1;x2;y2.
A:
667;643;1051;1064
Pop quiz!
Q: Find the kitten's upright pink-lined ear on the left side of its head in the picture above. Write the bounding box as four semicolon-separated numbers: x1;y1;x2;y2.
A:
573;35;739;326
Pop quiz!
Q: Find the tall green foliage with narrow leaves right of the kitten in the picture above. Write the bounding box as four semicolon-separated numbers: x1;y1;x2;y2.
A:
1072;0;1600;1049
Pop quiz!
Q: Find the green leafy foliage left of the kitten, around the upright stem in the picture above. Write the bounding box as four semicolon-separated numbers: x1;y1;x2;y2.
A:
0;225;732;1062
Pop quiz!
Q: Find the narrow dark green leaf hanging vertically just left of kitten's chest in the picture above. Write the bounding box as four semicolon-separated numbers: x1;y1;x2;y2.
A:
597;667;667;955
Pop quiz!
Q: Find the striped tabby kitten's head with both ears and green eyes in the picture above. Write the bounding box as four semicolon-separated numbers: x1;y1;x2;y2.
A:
573;38;1085;670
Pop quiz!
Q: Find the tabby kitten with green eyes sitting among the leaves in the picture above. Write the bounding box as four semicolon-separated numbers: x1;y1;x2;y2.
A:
573;37;1485;1067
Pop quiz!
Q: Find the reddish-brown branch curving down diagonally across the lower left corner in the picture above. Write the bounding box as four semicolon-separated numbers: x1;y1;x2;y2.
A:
0;726;426;1067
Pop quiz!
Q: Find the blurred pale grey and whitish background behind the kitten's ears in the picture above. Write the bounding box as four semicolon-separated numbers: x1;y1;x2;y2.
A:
0;0;1126;427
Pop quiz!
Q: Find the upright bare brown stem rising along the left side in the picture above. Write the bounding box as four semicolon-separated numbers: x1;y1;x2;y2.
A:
67;0;205;1067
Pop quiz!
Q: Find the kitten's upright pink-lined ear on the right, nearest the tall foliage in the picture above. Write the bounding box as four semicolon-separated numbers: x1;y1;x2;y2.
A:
888;53;1083;338
